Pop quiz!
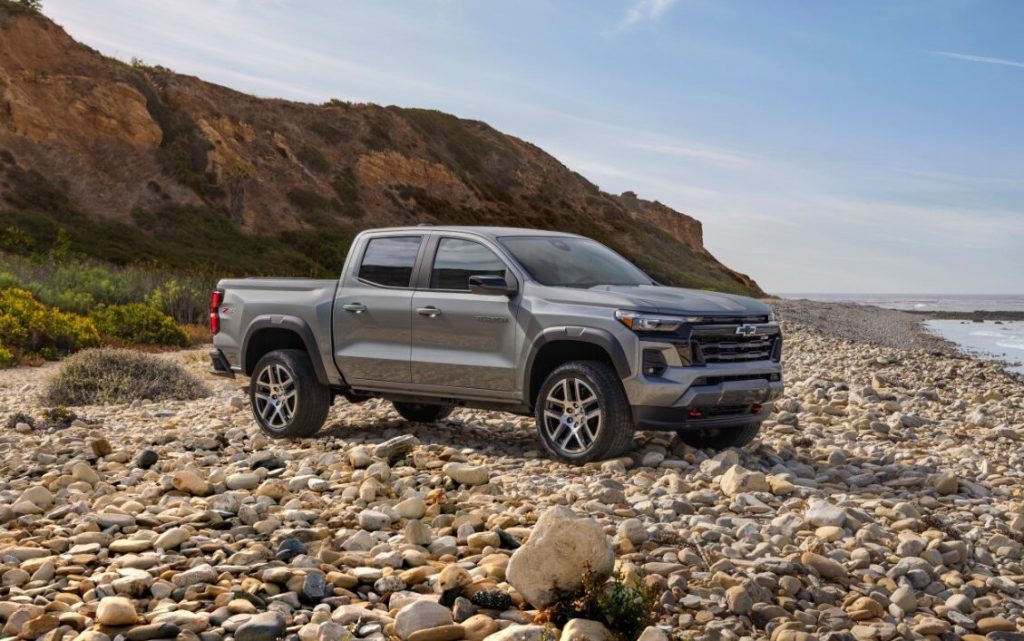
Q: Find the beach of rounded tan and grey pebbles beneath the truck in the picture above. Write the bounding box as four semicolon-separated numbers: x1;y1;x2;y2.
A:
0;301;1024;641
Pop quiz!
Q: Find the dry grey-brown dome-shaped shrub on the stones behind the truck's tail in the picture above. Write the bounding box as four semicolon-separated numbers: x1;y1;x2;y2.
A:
43;349;210;407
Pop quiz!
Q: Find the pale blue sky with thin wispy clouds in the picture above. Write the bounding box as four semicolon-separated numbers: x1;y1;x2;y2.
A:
43;0;1024;294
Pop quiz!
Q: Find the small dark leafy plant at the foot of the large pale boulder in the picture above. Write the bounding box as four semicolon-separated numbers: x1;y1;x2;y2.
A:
547;567;657;641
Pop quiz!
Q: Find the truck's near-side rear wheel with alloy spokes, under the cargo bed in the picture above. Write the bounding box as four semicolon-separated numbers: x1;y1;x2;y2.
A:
249;349;334;438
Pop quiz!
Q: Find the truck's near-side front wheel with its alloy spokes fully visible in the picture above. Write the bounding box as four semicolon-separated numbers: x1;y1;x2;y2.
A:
535;360;636;464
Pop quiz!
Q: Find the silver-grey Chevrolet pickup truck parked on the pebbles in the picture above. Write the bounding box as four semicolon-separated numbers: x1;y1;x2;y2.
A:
210;226;782;463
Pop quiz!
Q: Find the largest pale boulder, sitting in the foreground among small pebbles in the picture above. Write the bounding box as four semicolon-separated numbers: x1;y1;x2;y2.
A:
506;506;615;607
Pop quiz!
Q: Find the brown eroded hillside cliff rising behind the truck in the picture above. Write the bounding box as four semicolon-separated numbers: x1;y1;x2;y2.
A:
0;8;760;293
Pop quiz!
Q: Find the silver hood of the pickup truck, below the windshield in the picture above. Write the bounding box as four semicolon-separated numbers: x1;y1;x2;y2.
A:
544;285;771;315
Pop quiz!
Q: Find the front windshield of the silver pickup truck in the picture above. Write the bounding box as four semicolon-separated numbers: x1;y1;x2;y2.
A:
501;236;653;289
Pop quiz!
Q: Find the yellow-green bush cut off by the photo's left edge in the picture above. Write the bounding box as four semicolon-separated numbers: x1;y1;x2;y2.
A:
0;288;99;365
